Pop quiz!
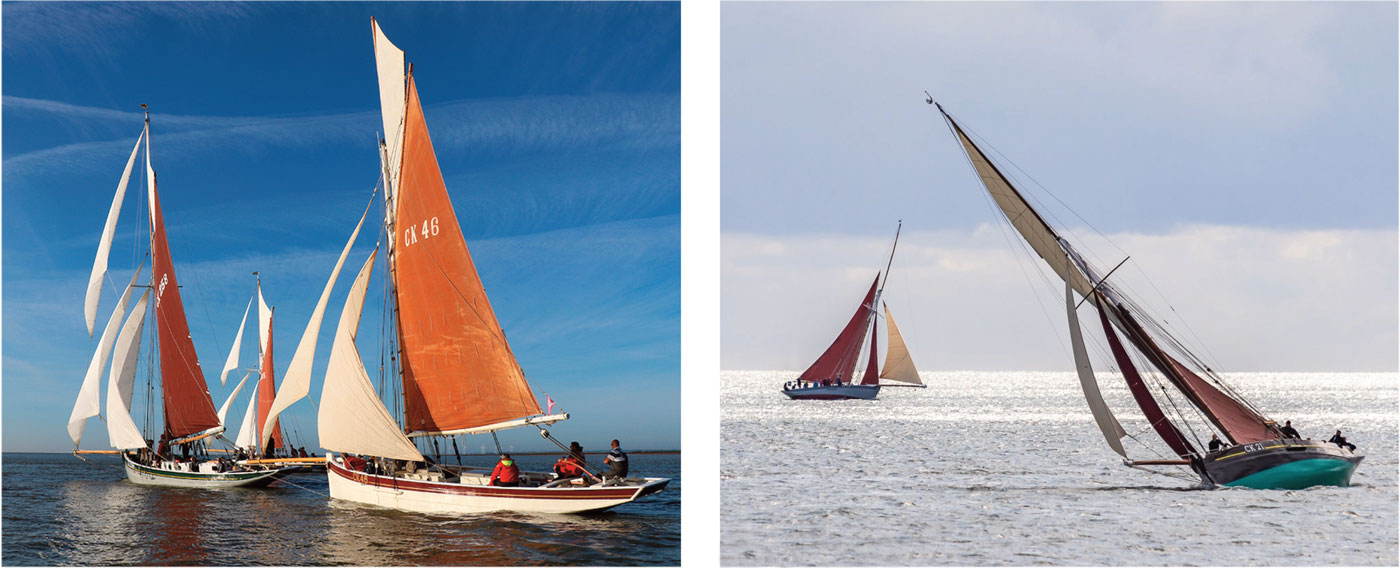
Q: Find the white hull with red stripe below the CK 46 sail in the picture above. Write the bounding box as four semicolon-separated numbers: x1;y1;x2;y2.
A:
326;456;671;513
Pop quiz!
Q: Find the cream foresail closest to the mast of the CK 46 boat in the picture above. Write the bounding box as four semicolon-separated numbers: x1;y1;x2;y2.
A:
316;249;423;462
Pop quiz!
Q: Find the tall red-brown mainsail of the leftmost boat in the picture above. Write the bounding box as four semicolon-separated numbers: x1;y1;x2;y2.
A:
150;185;218;439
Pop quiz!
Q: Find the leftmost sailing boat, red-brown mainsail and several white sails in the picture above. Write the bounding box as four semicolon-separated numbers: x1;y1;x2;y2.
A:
69;105;291;488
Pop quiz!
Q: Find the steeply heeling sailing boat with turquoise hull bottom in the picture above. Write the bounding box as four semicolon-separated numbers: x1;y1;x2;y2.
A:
930;101;1364;490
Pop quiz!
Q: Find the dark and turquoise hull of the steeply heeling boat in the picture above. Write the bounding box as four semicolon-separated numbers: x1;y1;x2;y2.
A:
1204;439;1365;490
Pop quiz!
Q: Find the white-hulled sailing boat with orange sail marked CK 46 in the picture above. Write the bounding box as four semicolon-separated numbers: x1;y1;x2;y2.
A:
302;18;671;513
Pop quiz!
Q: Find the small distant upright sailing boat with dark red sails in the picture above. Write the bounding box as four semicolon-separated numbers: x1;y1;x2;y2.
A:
783;221;918;400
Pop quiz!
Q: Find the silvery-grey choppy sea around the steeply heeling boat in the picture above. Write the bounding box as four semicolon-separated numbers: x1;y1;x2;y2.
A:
720;371;1400;567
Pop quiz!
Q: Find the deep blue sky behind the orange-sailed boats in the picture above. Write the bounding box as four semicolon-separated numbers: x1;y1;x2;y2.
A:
3;3;680;450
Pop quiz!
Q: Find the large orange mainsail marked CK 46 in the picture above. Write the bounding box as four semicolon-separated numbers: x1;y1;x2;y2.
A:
393;71;540;434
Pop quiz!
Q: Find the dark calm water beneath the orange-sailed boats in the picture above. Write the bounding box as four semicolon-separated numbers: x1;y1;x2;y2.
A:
0;453;680;565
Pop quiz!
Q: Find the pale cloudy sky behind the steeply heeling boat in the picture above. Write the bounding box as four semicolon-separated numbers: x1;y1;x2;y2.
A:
721;3;1397;371
